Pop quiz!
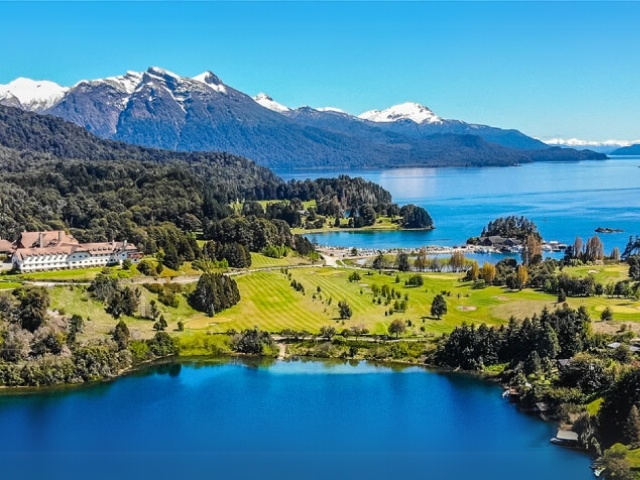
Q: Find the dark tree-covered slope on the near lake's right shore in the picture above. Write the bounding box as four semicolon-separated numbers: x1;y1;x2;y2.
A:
433;304;640;464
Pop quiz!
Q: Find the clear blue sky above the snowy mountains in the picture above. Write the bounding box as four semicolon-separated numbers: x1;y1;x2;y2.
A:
0;2;640;140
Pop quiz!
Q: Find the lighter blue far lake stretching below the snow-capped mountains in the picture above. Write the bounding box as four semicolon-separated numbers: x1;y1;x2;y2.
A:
276;157;640;254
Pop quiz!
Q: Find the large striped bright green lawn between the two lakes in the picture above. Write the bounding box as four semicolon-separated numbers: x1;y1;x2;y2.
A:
186;268;555;335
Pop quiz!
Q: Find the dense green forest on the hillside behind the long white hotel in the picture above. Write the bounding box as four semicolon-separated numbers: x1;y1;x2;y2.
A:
0;107;400;248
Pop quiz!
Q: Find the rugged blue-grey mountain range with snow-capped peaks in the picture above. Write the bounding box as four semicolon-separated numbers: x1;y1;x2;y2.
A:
0;67;606;168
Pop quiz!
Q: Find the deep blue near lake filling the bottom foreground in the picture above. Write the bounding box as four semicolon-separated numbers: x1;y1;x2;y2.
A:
0;360;593;480
